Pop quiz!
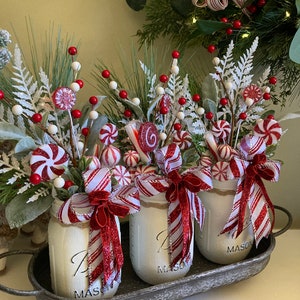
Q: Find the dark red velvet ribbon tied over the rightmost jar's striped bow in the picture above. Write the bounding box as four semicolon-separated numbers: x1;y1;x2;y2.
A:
237;154;275;236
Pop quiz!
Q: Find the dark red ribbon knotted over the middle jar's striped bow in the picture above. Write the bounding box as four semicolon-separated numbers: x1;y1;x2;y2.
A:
166;170;207;267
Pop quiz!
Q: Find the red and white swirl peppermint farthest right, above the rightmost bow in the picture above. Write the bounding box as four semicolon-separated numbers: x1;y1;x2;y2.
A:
254;119;282;146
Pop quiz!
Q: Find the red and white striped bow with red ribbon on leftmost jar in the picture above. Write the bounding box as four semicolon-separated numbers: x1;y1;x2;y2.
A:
58;168;140;290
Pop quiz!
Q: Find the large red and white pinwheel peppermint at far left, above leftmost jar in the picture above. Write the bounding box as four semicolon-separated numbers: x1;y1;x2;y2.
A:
30;144;68;181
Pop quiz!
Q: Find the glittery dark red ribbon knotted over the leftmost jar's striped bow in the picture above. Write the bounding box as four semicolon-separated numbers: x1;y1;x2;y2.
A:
88;191;129;285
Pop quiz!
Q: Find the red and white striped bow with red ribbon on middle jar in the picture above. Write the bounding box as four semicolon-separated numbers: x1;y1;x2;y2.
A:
135;144;212;267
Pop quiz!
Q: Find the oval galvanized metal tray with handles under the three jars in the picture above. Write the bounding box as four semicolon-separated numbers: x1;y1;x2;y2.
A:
0;207;292;300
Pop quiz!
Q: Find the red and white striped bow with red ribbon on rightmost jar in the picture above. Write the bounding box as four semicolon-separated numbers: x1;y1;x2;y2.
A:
222;154;280;245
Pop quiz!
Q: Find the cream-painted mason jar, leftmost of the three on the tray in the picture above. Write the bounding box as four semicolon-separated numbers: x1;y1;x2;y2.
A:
48;200;120;299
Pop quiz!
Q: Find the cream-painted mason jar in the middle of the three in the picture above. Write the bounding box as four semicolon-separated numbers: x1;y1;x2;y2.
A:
129;193;194;285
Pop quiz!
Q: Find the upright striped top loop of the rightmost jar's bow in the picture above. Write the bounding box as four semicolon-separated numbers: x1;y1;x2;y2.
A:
240;134;266;160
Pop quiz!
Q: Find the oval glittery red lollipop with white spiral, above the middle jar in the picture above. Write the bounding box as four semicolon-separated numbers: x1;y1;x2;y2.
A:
138;122;159;152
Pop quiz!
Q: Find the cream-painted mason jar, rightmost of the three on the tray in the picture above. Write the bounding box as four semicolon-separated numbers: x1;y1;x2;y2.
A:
195;180;254;264
